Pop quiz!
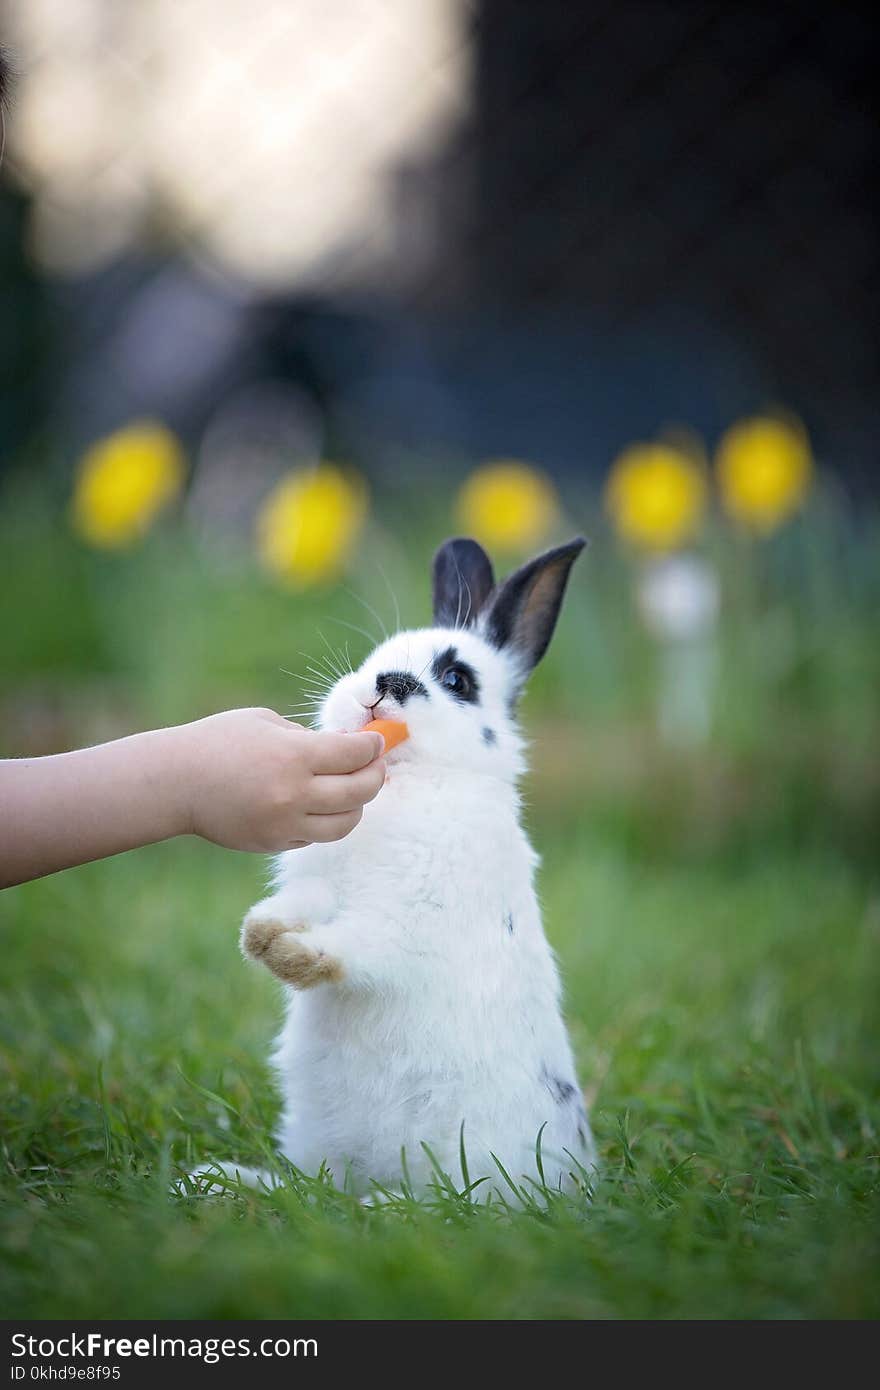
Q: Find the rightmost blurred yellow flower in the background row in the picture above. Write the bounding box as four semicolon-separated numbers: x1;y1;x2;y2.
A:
716;417;813;534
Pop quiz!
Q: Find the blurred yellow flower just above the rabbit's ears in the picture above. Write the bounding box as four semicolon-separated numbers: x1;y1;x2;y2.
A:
456;459;559;550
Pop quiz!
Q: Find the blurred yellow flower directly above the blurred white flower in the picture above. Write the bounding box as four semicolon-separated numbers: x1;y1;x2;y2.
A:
605;443;708;550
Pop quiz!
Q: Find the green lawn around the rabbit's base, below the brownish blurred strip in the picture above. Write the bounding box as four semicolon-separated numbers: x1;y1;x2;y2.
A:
0;833;880;1318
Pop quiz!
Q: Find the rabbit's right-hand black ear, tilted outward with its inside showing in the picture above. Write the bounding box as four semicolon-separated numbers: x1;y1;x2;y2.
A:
487;535;587;674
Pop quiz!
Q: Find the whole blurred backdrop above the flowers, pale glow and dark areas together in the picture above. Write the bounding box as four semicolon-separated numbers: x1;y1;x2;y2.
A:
0;0;880;487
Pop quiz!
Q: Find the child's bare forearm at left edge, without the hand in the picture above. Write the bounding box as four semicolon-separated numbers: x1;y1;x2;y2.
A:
0;728;192;888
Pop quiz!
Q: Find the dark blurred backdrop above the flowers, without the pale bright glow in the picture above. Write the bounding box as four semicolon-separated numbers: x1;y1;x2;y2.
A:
0;0;880;492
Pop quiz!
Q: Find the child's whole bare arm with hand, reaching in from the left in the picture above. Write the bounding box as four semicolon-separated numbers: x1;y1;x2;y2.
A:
0;709;385;887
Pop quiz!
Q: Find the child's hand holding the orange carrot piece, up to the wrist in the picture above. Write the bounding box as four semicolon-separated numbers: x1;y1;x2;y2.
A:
175;709;385;853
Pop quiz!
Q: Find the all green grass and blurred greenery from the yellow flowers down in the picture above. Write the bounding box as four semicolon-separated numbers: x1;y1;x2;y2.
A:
0;483;880;1318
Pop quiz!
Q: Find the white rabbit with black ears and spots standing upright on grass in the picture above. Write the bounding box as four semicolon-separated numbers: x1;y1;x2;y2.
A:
234;539;594;1197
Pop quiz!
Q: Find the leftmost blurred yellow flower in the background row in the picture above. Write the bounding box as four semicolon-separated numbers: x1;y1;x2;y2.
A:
71;420;185;549
